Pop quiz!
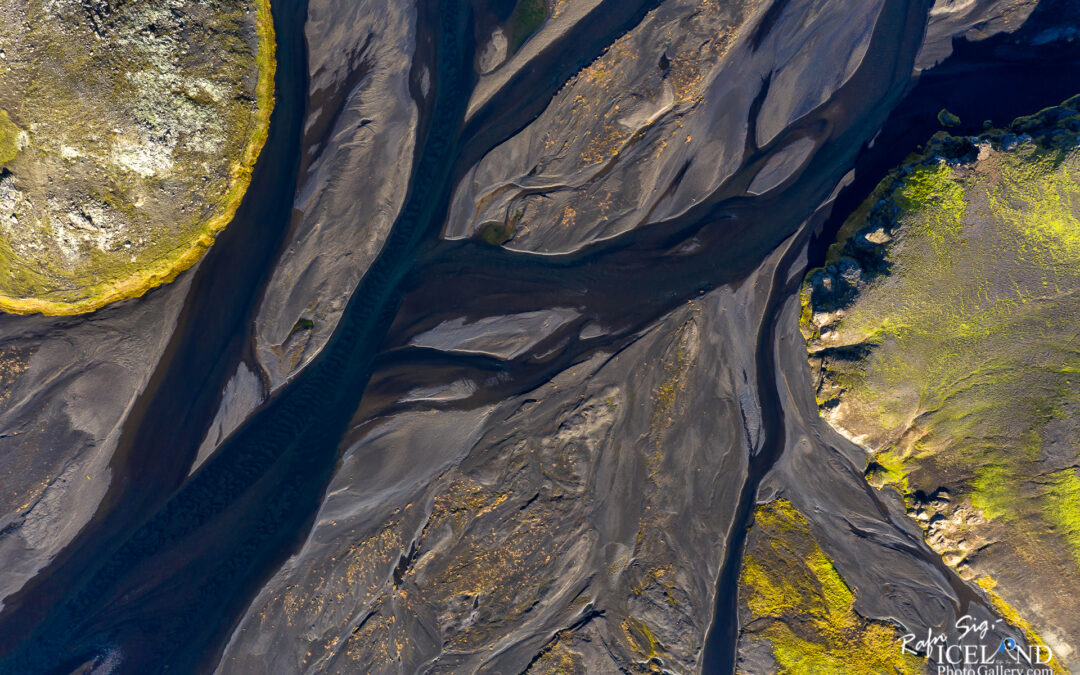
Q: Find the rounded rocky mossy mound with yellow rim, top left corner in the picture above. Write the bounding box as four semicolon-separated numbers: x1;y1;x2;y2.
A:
0;0;273;314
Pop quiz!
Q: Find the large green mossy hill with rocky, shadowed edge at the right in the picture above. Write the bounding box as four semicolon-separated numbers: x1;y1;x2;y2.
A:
801;100;1080;665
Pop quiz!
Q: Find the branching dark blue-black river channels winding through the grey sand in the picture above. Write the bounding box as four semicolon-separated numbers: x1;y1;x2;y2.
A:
0;0;1080;675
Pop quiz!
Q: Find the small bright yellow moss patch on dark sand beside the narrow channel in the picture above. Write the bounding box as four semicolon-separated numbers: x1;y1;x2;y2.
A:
739;499;923;675
